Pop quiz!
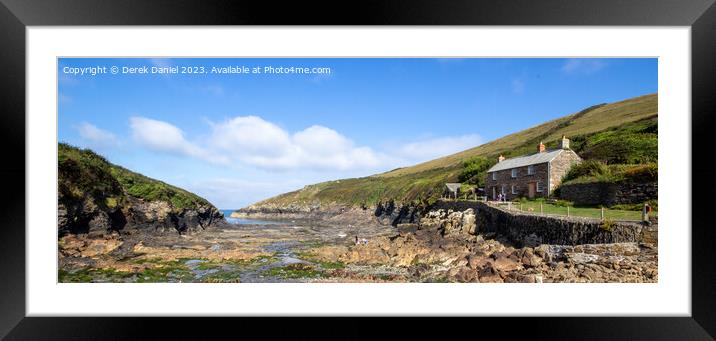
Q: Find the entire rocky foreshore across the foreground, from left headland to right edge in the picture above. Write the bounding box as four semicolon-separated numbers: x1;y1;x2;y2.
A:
60;201;658;283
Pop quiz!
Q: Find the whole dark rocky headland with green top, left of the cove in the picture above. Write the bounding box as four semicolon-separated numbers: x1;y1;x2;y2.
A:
57;143;226;236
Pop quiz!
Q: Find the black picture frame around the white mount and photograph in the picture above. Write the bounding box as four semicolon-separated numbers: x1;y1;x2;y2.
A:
0;0;716;340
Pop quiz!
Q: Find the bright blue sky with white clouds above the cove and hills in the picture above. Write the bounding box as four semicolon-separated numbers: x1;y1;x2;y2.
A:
58;58;658;209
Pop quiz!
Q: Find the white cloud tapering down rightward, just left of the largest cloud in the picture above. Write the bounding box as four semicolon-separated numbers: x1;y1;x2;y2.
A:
129;116;226;163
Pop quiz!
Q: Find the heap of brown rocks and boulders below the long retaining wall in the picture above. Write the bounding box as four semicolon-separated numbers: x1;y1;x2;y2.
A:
304;212;658;283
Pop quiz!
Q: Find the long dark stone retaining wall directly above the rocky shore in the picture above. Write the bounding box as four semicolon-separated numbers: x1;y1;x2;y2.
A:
430;201;658;247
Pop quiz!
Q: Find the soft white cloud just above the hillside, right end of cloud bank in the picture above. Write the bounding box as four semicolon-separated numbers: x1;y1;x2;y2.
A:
397;134;482;162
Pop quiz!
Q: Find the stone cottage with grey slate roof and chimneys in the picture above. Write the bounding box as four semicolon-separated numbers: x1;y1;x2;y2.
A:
485;136;582;200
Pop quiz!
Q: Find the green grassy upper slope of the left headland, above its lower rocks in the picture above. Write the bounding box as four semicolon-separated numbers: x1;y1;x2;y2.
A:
57;143;210;210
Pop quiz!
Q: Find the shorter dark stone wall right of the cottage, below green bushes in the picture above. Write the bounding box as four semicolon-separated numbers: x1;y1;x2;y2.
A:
559;181;659;206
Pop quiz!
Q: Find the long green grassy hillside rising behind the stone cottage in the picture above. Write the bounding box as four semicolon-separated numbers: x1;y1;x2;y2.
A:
249;94;658;206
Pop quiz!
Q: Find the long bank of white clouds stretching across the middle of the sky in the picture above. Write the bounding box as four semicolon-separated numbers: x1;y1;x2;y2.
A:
130;116;482;172
